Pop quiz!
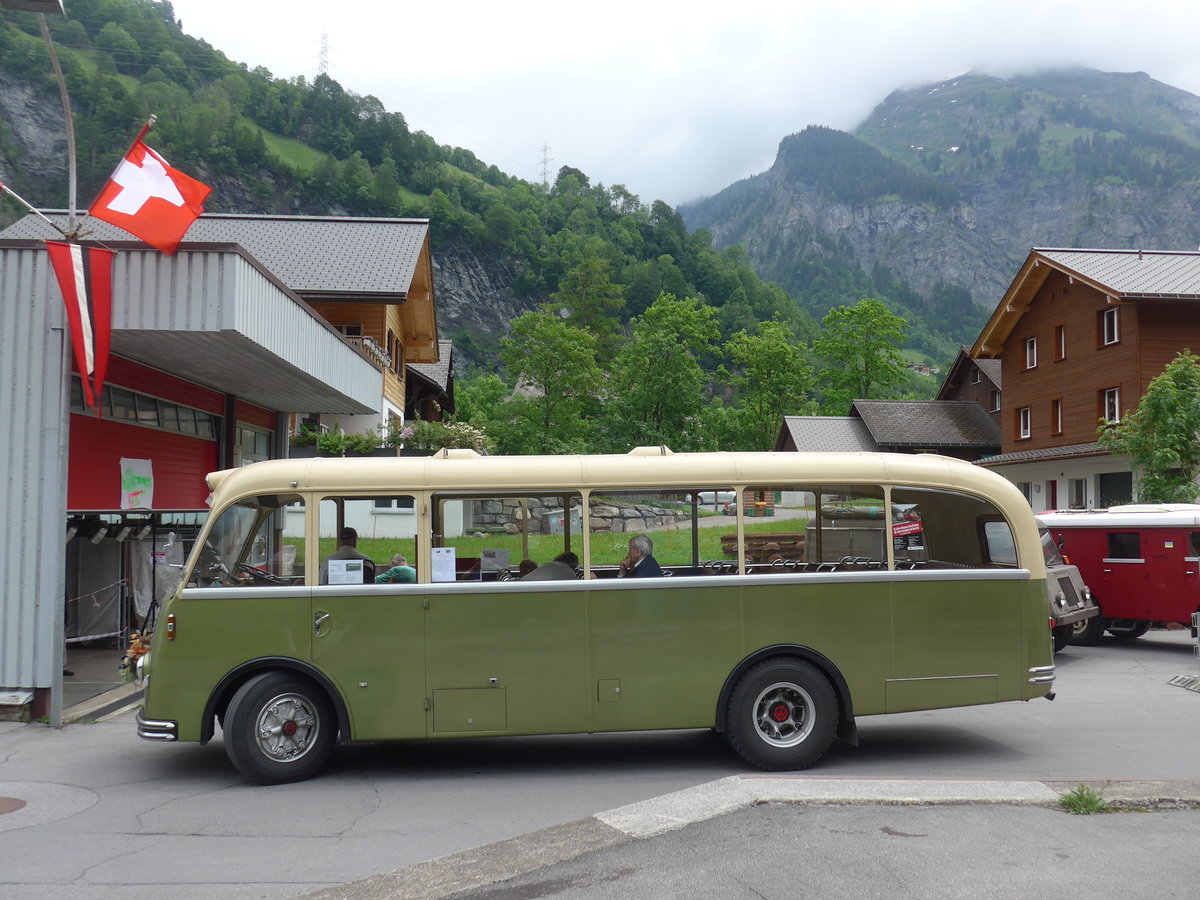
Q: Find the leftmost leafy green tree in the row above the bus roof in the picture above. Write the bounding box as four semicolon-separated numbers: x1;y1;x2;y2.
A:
500;312;601;454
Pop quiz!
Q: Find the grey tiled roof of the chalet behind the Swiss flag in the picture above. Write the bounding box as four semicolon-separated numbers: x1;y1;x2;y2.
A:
0;212;430;299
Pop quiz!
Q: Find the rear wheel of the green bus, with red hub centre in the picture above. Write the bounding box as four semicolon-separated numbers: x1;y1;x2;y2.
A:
725;658;838;772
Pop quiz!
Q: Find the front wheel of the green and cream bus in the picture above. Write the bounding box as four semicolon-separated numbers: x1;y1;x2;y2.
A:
224;672;337;785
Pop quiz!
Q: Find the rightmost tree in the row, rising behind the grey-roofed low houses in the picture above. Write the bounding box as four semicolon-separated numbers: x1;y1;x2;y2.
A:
812;298;908;415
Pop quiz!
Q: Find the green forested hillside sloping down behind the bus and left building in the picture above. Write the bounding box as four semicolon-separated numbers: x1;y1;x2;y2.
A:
0;0;954;452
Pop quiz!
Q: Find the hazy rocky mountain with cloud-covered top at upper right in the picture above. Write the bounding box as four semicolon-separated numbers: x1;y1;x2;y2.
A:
679;68;1200;341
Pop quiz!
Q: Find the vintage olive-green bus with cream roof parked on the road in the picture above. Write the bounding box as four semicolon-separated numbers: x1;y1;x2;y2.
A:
137;448;1055;784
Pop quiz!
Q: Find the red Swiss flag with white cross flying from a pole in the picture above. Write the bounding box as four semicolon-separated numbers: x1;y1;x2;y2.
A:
88;125;212;256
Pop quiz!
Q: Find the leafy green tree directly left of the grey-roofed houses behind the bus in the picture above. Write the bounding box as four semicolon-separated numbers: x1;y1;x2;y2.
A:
722;322;816;450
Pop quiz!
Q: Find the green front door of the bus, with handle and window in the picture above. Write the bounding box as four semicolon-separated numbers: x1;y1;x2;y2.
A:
308;494;427;740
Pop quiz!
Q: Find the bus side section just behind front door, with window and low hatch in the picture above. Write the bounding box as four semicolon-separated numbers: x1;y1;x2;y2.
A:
425;493;590;737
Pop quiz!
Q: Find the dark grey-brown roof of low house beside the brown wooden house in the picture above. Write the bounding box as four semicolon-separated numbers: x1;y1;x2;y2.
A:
851;400;1000;449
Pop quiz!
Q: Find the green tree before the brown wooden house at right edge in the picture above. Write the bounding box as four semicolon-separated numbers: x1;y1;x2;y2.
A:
1098;350;1200;503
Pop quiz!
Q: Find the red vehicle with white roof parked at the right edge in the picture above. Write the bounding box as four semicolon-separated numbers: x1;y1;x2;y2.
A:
1038;503;1200;646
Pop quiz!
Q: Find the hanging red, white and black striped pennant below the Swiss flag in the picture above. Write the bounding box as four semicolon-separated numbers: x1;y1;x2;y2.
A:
46;241;116;408
